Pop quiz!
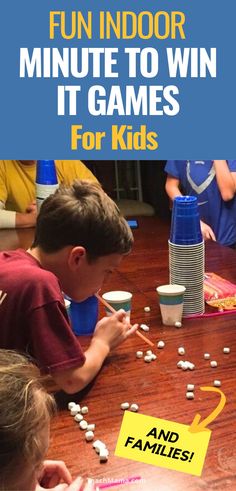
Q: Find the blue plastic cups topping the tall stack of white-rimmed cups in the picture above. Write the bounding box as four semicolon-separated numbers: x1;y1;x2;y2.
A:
170;196;203;245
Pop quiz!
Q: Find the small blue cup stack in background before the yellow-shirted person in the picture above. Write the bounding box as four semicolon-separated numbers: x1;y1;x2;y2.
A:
36;160;58;210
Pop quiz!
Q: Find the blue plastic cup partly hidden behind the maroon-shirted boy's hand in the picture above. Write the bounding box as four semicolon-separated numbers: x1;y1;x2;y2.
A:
68;296;98;336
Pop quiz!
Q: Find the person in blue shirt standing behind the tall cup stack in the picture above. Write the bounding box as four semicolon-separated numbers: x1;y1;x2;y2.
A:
165;160;236;247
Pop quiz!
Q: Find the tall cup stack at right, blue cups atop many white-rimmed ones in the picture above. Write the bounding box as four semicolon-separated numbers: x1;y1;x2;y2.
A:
169;196;205;315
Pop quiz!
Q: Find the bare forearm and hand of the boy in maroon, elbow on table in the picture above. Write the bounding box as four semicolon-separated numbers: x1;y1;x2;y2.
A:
53;310;138;394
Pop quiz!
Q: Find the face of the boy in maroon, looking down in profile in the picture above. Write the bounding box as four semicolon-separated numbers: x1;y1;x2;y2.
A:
63;254;123;302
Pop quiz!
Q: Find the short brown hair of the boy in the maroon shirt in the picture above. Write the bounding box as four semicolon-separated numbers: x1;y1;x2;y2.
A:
32;180;133;260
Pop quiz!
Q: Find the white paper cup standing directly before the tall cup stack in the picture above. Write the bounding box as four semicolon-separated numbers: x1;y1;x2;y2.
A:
156;285;186;326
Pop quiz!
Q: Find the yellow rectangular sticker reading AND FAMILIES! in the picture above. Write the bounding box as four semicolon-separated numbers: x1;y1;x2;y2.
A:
115;411;211;476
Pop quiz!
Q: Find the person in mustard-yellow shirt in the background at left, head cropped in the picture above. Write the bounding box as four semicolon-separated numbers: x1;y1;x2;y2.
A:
0;160;97;228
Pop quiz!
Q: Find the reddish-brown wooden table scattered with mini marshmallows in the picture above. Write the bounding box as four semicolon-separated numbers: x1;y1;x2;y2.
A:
0;217;236;491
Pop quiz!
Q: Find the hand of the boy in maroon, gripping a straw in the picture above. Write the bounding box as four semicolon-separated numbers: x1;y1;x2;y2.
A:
93;310;138;350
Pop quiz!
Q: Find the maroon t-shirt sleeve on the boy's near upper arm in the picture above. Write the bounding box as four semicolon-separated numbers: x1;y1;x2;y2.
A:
27;301;85;373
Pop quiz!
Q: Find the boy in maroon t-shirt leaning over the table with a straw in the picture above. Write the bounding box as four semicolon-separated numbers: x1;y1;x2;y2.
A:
0;181;137;393
